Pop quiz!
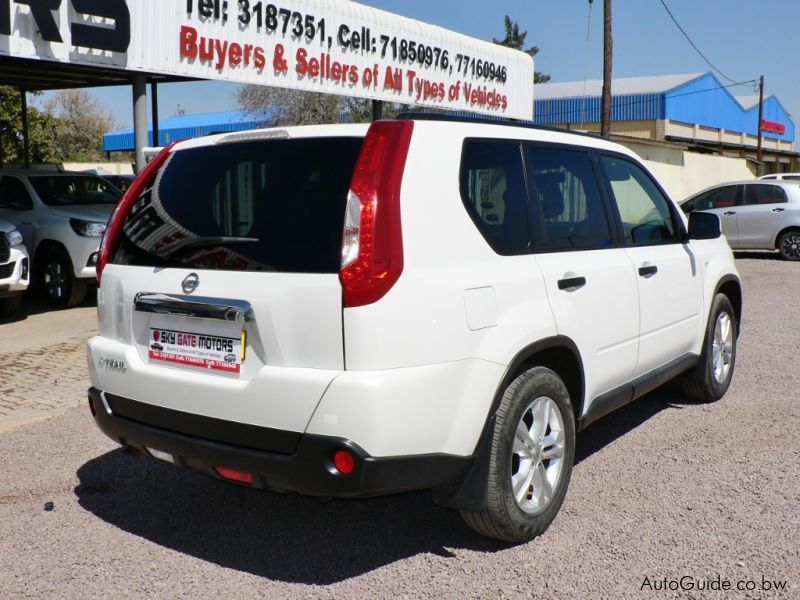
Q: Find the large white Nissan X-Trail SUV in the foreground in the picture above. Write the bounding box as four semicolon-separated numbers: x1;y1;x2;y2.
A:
84;115;742;541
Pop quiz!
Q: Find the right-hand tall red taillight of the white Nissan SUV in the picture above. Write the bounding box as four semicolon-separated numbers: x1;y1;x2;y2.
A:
339;121;414;308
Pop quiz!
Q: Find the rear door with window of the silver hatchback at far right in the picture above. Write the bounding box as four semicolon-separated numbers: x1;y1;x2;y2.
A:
737;183;789;249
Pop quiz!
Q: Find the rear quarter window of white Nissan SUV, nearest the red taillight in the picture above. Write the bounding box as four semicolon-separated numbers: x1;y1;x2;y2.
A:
461;140;530;255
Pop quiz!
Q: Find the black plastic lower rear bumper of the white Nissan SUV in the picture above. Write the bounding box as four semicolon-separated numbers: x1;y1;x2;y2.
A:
89;388;473;497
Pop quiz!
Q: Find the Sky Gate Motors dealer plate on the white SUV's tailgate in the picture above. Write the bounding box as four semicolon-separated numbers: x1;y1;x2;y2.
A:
148;327;246;373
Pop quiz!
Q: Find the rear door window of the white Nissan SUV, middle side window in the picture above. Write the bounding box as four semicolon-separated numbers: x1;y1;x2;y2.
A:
528;146;612;250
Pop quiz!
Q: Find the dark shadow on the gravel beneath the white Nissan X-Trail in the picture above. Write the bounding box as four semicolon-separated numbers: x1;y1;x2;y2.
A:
75;388;687;585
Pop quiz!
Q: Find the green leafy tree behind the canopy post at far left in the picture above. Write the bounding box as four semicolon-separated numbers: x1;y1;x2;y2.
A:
0;86;55;164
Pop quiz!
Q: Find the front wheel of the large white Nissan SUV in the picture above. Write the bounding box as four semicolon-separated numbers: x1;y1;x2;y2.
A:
681;294;739;402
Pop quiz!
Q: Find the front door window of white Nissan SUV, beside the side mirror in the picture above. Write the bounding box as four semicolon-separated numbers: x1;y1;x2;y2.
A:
601;156;680;246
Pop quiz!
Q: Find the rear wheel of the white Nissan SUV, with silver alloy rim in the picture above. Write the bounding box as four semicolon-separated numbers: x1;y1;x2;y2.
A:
461;367;575;543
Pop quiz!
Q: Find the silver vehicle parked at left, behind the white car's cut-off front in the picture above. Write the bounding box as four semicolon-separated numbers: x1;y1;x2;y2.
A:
0;170;120;307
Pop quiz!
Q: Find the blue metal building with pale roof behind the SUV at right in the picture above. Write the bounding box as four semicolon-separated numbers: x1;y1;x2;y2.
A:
534;73;800;172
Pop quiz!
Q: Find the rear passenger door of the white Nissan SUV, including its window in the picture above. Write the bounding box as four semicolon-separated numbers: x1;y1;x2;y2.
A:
527;145;639;408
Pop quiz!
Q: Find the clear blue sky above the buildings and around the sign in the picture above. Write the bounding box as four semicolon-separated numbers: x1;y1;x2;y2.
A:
53;0;800;132
